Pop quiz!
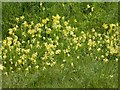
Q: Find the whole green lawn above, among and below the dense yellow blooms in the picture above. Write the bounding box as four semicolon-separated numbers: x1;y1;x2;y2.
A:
2;2;120;88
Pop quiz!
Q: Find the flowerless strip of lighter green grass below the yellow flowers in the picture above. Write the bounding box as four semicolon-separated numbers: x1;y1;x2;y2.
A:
2;59;118;88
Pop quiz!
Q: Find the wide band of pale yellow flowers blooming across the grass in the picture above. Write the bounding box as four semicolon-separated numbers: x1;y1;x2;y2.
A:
0;14;119;72
